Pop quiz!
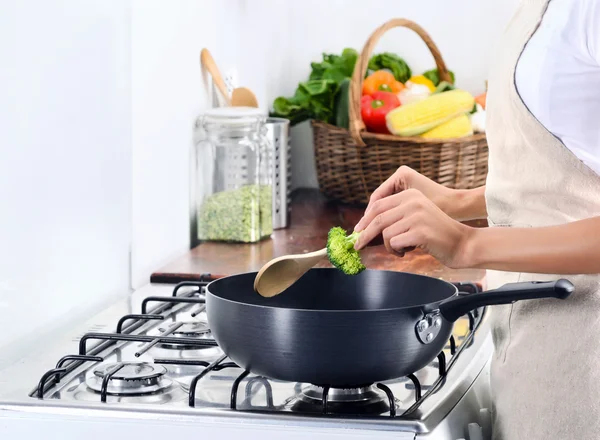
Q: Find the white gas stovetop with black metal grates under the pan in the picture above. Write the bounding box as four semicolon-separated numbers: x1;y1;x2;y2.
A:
0;276;489;432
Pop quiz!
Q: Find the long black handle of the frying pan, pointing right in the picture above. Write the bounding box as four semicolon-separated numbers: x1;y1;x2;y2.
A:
438;278;575;322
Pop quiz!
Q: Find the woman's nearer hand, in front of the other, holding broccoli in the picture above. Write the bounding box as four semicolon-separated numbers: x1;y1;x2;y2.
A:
355;189;472;268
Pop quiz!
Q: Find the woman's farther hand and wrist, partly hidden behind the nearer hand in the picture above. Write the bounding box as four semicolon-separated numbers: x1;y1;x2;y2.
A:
365;166;487;220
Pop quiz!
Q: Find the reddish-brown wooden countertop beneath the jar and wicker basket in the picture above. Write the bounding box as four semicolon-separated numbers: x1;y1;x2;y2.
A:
151;190;485;285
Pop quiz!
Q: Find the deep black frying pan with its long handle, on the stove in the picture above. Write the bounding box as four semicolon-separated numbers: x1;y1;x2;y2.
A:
206;269;574;388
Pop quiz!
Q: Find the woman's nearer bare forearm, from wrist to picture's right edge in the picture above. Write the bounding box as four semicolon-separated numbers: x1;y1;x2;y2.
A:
463;217;600;274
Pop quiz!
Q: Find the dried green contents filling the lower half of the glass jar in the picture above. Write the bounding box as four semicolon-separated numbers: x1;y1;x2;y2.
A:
198;185;273;243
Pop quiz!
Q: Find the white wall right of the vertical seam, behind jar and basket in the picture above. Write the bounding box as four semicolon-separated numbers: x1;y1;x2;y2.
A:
132;0;518;286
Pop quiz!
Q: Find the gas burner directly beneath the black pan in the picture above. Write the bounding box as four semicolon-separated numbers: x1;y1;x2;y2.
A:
291;385;390;415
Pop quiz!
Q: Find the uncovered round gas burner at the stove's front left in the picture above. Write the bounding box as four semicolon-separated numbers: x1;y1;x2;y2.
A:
86;362;172;396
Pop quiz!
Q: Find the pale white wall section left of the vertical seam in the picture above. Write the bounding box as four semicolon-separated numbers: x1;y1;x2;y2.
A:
0;0;131;365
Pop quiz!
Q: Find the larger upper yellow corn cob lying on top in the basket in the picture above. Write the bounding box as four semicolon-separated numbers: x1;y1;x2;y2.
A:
386;89;475;136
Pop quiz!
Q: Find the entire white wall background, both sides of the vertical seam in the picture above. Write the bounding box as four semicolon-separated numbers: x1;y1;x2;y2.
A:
0;0;518;364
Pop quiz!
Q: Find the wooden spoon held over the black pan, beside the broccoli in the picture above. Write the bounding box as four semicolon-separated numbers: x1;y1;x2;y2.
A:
254;248;327;298
